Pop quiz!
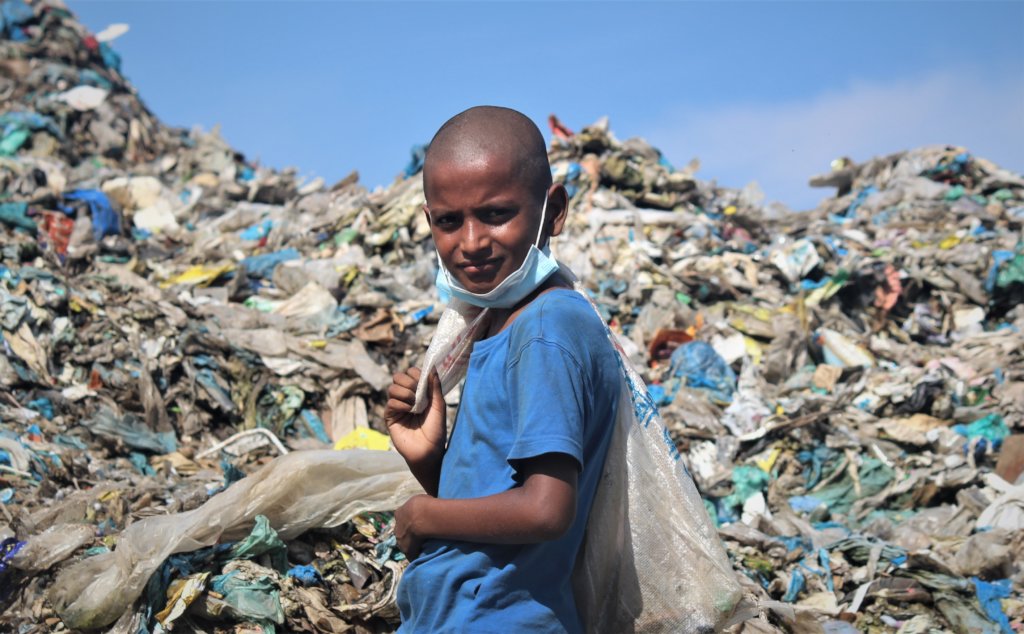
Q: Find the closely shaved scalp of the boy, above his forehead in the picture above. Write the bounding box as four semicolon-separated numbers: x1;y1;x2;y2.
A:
423;105;551;202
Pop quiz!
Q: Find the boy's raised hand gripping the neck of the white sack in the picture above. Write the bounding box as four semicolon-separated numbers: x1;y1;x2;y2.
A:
384;368;447;481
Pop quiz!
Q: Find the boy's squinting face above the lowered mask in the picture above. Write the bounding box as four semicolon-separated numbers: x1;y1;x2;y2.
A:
424;156;561;293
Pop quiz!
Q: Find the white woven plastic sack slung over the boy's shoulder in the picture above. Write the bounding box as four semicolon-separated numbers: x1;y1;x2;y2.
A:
414;284;741;634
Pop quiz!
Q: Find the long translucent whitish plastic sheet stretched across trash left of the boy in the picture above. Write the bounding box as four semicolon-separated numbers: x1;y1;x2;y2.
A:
50;450;423;629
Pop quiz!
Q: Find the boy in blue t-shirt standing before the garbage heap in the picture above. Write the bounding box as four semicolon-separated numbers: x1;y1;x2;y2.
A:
385;107;622;633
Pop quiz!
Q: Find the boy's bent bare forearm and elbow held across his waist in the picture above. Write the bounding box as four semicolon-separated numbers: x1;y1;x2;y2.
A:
395;454;579;559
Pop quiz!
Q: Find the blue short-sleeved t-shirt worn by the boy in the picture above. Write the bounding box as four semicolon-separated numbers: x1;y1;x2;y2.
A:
397;289;622;634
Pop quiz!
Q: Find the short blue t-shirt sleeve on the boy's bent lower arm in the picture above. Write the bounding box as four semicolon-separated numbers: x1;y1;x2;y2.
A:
506;319;588;471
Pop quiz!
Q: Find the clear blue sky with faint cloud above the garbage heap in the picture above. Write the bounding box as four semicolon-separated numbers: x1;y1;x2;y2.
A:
69;0;1024;209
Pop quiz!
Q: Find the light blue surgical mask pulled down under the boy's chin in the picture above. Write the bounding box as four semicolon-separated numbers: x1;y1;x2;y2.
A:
434;196;558;308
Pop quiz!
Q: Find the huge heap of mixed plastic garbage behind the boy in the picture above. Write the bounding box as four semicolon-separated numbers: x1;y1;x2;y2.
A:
0;0;1024;634
